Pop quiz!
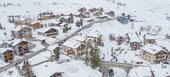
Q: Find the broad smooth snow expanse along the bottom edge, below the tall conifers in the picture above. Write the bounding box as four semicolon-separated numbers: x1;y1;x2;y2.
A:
33;60;102;77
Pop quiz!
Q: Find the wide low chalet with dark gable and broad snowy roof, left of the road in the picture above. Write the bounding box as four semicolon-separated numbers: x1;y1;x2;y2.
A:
38;28;58;38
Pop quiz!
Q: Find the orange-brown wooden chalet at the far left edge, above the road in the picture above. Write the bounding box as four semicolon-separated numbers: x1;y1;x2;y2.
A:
0;48;14;62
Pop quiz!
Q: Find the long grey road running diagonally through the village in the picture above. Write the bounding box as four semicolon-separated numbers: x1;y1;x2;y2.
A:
0;18;115;73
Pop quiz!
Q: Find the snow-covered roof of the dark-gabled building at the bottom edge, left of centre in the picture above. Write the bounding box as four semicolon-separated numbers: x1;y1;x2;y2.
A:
33;62;65;77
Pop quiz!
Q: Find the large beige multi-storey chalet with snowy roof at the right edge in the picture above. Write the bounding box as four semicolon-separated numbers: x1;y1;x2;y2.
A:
140;44;169;64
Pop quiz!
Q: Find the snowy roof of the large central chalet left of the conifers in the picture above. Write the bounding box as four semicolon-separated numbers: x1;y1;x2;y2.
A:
62;39;81;49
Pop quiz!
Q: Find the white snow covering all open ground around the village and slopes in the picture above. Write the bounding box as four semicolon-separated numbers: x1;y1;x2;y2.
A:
0;0;170;77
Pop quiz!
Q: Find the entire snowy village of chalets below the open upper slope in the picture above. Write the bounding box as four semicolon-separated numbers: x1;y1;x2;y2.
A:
0;2;170;77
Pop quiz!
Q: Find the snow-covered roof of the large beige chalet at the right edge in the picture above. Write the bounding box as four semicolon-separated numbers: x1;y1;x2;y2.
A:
141;44;164;54
